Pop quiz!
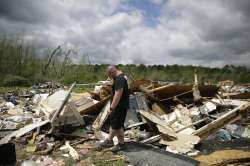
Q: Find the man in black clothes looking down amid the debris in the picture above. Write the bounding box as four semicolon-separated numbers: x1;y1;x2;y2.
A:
100;66;129;152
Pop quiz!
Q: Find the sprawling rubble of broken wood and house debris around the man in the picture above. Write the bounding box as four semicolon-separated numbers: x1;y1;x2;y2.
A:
0;79;250;165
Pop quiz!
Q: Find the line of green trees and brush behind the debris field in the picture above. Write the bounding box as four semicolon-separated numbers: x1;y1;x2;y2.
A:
0;37;250;86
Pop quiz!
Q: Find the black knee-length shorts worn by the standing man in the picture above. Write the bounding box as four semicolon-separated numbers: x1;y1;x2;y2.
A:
109;107;127;130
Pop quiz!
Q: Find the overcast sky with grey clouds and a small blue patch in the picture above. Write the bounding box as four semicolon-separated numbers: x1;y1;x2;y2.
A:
0;0;250;67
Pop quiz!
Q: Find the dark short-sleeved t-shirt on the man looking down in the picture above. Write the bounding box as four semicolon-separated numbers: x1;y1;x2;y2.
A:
111;74;129;109
